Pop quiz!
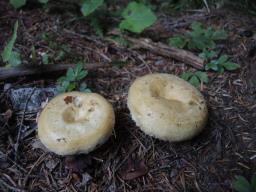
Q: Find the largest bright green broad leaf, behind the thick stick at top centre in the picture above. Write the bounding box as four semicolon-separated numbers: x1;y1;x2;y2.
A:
119;2;157;33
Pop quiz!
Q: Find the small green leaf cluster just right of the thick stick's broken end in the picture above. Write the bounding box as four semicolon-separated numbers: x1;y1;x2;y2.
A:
205;55;240;73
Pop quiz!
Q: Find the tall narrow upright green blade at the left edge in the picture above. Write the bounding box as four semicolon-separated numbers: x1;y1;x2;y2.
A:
1;21;19;62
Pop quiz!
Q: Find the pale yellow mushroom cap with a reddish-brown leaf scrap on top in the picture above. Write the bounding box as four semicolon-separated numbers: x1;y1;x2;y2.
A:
38;92;115;155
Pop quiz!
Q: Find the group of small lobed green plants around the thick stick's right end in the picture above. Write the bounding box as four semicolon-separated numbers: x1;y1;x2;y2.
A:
169;22;240;79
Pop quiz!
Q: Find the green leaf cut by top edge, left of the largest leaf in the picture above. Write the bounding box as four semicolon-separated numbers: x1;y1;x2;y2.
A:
81;0;104;16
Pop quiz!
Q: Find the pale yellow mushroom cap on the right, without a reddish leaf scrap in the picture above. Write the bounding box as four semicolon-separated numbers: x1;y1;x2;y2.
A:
127;73;208;142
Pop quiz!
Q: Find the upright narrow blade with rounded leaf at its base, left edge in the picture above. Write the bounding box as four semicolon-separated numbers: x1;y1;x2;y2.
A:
1;21;21;67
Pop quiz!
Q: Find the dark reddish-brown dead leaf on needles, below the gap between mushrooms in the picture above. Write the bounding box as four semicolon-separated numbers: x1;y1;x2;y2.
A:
119;157;148;180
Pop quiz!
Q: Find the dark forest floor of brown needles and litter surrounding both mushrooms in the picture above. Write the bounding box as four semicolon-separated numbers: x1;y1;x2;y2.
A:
0;1;256;192
